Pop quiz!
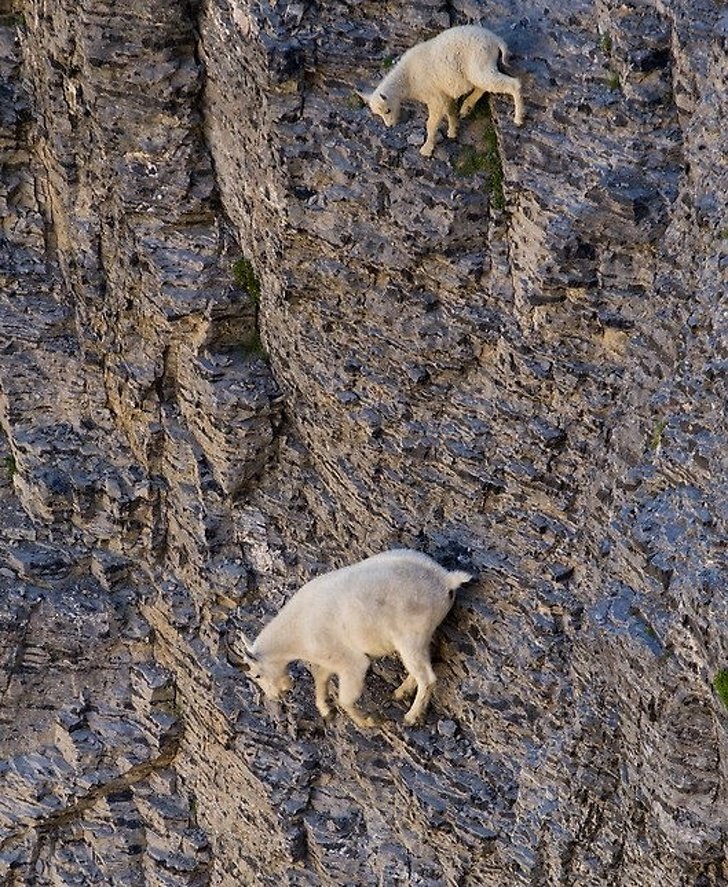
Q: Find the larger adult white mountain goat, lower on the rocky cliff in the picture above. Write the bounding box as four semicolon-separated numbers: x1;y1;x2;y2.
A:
236;549;472;727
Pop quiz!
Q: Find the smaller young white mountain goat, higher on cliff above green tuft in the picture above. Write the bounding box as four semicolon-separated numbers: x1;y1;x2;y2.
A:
359;25;523;157
